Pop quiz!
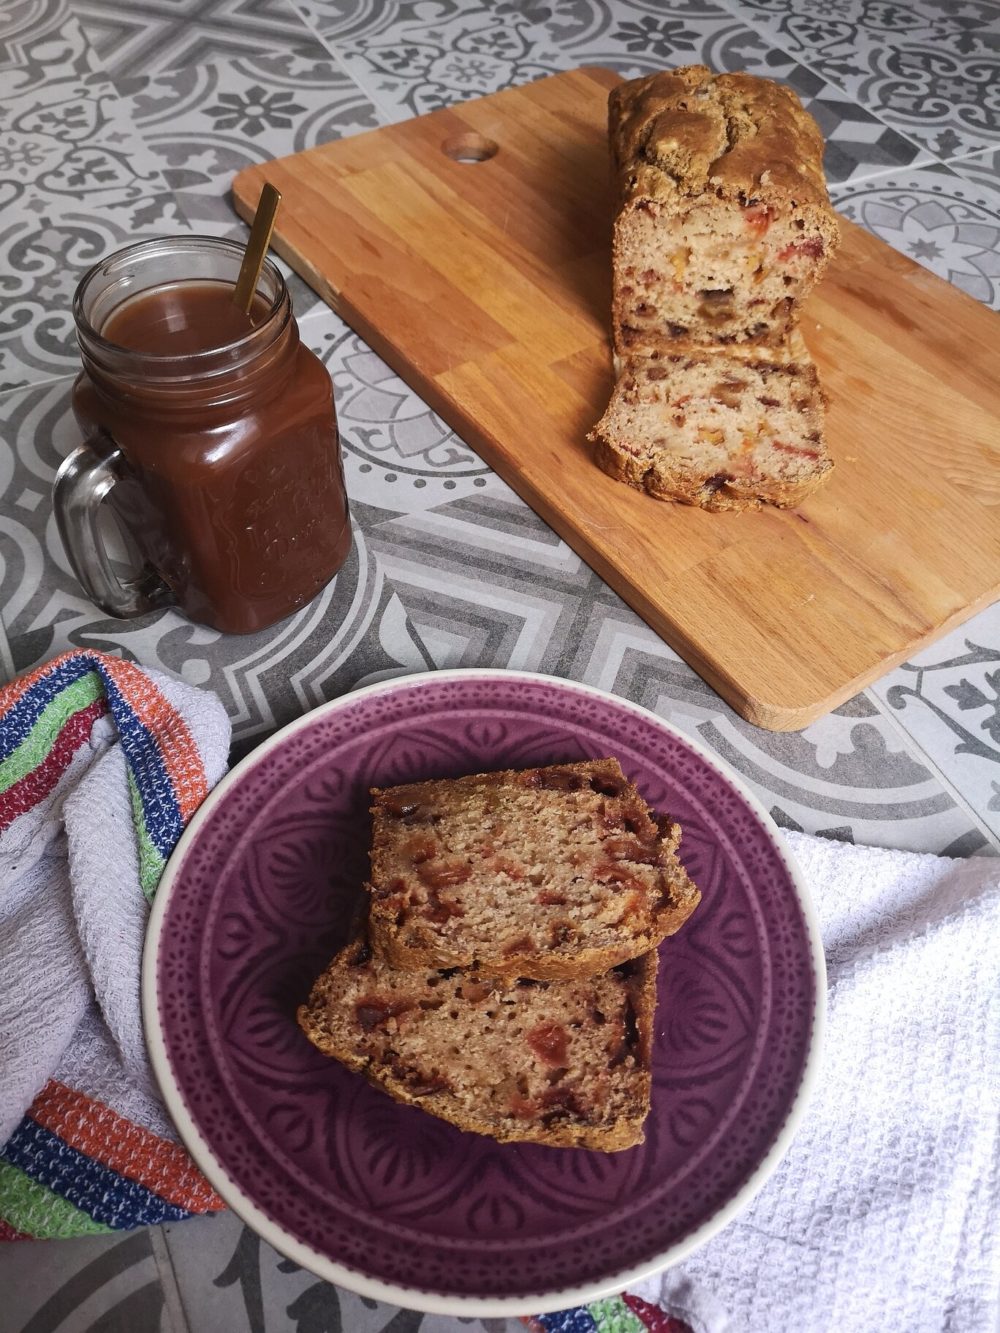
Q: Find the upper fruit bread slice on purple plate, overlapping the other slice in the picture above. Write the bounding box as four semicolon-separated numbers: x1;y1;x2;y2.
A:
369;758;700;980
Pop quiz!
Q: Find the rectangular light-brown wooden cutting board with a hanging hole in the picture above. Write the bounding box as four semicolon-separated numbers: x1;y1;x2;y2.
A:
235;69;1000;730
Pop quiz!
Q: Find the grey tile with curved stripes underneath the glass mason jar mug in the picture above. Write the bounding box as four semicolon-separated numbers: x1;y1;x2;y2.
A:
0;380;432;753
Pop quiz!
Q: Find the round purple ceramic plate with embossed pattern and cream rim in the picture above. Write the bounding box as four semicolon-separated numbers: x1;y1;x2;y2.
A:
143;670;824;1316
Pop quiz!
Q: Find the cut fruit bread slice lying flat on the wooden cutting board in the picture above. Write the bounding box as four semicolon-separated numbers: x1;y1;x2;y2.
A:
589;336;833;511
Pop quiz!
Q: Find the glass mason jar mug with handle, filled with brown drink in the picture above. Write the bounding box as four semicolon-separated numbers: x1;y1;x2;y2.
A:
53;237;351;635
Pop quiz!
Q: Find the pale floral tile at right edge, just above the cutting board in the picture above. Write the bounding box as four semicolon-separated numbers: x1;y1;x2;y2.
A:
833;165;1000;309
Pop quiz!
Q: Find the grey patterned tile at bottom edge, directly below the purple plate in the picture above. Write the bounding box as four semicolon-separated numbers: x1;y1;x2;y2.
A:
164;1213;524;1333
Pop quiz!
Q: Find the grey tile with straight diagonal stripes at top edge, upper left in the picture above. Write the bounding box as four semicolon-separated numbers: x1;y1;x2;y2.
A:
69;0;318;76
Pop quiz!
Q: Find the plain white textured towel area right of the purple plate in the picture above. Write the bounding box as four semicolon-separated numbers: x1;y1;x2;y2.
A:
635;834;1000;1333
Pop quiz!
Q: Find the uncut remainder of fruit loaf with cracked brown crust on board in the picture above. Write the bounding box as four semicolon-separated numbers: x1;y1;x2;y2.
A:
609;65;840;356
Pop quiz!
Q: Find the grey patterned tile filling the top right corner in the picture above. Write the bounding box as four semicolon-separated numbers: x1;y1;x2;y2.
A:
725;0;1000;161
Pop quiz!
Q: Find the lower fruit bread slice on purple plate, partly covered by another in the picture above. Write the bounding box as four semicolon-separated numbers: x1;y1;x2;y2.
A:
299;938;656;1152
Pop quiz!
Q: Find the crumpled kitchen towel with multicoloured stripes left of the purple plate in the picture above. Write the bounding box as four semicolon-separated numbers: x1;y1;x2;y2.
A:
0;651;229;1240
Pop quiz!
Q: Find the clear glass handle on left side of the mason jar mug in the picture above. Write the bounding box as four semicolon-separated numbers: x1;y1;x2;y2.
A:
52;435;173;619
